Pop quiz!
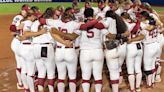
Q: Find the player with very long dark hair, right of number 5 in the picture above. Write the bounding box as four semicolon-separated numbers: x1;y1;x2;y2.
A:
102;11;129;92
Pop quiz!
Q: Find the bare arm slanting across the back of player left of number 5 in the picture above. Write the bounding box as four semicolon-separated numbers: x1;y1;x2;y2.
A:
50;28;79;40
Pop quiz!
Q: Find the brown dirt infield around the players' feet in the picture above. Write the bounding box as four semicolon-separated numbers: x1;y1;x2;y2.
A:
0;13;164;92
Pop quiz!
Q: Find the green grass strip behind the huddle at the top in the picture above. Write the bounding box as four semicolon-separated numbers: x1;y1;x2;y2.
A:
0;2;164;15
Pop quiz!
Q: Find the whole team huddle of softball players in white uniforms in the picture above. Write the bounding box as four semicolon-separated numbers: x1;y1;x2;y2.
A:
10;0;164;92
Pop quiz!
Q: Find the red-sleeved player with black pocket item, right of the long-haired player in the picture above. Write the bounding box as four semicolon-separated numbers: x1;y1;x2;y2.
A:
121;13;144;92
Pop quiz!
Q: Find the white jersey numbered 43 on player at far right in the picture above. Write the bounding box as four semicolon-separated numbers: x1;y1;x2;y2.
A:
141;22;158;44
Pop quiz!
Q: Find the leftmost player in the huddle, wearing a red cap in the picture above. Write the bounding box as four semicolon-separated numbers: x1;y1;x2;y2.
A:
10;5;29;89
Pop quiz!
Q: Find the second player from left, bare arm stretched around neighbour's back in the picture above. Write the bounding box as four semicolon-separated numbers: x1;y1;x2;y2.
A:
19;10;46;92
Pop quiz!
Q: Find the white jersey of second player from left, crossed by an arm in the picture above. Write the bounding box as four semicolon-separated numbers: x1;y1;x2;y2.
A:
22;20;33;43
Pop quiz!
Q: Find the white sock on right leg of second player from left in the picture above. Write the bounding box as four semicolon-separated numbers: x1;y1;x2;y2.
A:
27;75;35;92
